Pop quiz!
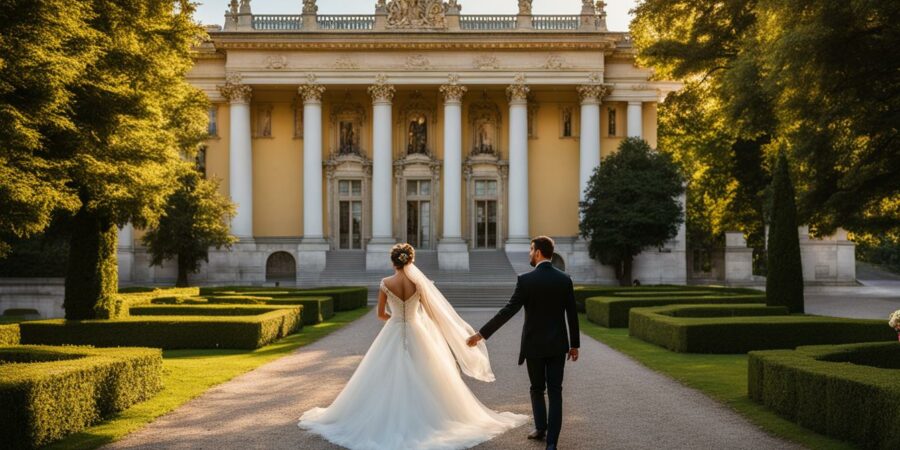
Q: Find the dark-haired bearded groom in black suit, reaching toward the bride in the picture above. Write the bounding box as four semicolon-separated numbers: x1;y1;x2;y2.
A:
467;236;580;450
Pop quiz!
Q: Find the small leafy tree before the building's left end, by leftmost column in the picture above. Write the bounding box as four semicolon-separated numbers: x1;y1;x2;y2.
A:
143;167;237;287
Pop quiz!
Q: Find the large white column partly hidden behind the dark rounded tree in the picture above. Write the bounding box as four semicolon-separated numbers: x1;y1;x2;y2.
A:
577;84;608;201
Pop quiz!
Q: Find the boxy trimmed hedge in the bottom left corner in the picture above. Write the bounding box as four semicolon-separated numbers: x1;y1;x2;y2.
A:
0;346;162;449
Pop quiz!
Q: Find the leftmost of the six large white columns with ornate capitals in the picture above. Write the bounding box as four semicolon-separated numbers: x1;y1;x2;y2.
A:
219;73;253;241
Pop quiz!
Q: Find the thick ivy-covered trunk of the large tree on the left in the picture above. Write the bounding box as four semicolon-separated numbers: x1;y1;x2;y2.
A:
63;208;119;320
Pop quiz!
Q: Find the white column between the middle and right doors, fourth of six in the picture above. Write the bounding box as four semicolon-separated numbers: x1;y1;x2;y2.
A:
438;74;469;271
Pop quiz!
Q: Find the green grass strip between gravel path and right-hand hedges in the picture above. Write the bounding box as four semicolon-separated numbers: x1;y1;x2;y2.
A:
579;314;856;450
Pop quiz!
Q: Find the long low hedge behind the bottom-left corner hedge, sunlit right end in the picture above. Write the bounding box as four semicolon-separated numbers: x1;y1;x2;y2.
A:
19;305;303;349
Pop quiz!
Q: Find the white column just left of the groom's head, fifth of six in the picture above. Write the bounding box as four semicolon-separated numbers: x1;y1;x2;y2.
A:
505;74;531;253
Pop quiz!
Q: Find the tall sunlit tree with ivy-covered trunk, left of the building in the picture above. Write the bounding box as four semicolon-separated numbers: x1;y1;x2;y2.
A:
54;0;208;319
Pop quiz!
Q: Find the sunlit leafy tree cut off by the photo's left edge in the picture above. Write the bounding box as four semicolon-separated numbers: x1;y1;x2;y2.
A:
0;0;98;257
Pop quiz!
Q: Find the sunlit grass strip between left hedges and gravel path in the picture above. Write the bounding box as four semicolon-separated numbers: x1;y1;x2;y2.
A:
46;308;369;450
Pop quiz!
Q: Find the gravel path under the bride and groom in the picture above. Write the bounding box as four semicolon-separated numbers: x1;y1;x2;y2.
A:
107;309;795;450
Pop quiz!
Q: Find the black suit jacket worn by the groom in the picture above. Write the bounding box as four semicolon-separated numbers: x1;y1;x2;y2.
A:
479;262;581;364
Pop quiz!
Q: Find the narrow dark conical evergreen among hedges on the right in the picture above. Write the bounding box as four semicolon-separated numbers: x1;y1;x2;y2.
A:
766;152;803;313
